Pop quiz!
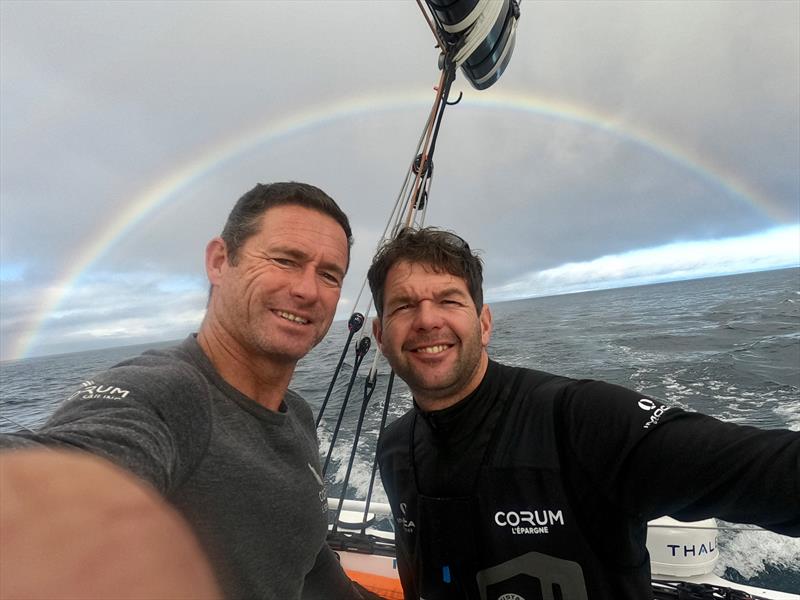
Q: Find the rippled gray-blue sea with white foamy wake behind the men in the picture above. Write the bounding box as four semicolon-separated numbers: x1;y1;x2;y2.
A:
0;268;800;593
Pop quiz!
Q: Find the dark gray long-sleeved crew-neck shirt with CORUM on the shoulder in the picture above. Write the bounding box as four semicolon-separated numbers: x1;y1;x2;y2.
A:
0;336;357;600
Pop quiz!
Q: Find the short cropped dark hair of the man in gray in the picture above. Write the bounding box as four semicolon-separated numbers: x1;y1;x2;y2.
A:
220;181;353;265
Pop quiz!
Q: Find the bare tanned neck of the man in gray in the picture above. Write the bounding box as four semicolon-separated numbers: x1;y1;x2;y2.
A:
197;315;296;412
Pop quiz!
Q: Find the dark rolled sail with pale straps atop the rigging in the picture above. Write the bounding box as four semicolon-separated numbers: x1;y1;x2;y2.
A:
425;0;519;90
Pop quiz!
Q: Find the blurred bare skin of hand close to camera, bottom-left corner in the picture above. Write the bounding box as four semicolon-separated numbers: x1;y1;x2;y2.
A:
0;450;222;600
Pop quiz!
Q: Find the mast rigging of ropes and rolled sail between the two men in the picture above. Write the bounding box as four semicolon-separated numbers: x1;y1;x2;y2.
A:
316;0;520;553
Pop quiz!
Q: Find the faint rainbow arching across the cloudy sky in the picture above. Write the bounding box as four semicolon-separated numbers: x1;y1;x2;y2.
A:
11;90;792;359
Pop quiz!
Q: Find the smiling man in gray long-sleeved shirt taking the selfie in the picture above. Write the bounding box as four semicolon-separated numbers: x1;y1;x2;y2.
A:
0;183;376;600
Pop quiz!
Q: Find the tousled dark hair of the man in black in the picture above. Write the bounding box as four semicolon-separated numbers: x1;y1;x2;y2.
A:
367;227;483;318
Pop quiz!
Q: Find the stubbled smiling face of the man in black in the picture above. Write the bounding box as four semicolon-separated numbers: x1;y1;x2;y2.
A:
373;261;492;410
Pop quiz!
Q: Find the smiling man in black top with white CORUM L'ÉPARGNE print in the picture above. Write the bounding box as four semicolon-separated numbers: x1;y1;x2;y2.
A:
368;228;800;600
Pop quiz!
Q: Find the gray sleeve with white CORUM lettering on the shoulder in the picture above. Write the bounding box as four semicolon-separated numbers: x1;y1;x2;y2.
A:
0;357;211;495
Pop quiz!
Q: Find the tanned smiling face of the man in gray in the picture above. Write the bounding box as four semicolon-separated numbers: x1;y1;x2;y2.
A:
206;205;348;368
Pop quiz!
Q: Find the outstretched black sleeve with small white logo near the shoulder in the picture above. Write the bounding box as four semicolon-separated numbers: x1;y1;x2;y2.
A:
562;382;800;536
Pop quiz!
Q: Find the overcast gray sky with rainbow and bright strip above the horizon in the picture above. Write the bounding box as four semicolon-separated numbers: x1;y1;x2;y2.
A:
0;0;800;359
